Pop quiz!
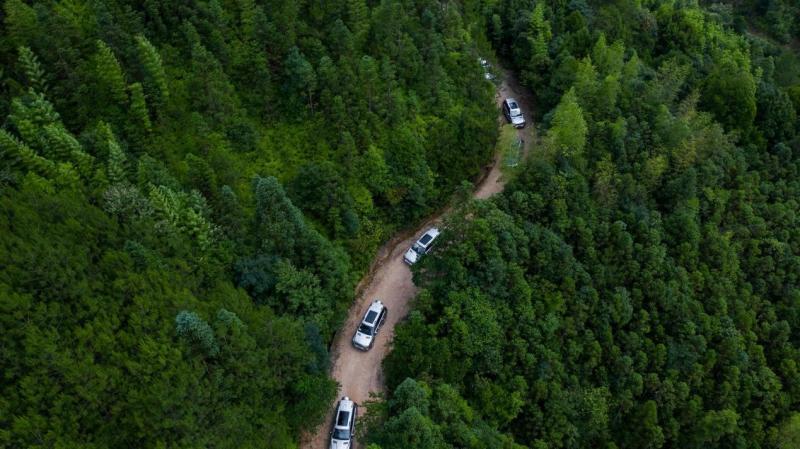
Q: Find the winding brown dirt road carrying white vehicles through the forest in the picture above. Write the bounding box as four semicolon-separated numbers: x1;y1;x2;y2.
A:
300;68;535;449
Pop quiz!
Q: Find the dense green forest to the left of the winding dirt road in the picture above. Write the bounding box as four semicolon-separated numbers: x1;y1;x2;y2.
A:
0;0;497;449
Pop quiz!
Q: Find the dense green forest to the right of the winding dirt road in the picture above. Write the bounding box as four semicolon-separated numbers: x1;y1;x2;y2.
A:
368;0;800;449
